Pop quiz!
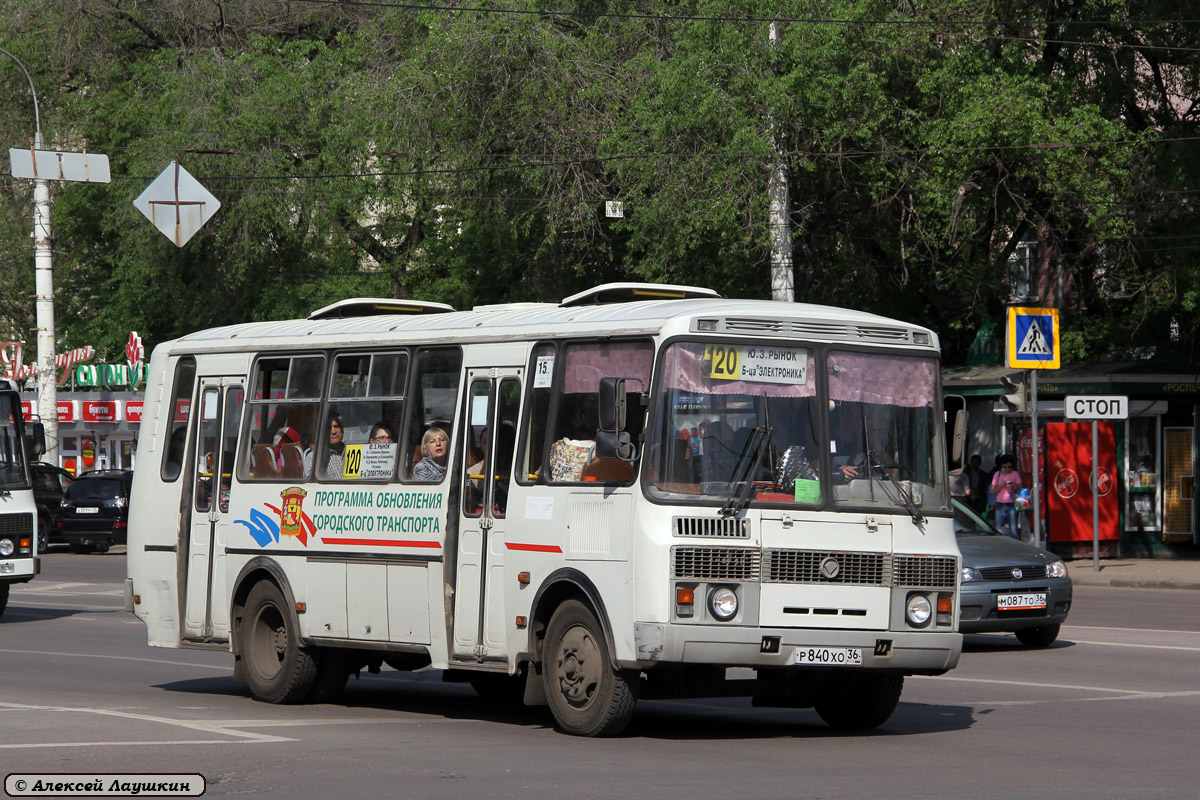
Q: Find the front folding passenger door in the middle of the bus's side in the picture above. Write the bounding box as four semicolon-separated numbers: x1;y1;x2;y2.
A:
452;367;522;662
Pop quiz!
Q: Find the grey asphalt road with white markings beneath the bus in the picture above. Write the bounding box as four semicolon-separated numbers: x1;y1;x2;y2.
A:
0;552;1200;800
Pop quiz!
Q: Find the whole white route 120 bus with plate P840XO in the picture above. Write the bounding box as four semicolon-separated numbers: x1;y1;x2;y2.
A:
126;284;961;735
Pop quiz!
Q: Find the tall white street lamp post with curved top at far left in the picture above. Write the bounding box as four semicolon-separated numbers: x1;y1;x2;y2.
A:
0;47;59;464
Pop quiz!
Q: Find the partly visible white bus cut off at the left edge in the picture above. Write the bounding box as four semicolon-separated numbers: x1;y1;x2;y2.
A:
0;378;46;614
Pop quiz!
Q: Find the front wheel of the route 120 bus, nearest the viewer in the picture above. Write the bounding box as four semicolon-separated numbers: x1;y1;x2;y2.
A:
542;600;637;736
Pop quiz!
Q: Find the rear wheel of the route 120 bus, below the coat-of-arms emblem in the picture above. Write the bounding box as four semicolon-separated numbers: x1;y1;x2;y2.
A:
238;581;317;704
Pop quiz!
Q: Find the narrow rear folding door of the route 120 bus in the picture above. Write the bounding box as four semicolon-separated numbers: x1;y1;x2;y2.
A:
181;378;246;640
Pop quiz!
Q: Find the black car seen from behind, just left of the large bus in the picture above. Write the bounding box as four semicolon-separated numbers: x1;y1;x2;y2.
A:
59;469;133;553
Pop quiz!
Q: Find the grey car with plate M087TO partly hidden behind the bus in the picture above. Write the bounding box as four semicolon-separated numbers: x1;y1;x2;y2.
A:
953;498;1070;648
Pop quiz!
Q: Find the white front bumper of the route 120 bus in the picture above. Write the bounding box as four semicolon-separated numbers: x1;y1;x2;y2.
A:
622;622;962;675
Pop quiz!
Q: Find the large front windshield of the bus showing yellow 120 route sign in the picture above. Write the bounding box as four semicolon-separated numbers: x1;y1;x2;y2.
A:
646;342;948;517
